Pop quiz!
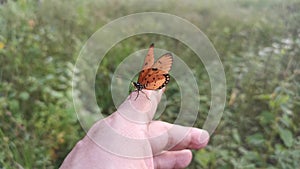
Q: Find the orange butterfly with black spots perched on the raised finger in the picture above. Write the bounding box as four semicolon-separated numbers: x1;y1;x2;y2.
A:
132;43;173;100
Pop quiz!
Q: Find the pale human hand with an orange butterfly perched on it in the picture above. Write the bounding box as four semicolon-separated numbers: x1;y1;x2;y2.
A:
61;89;209;169
